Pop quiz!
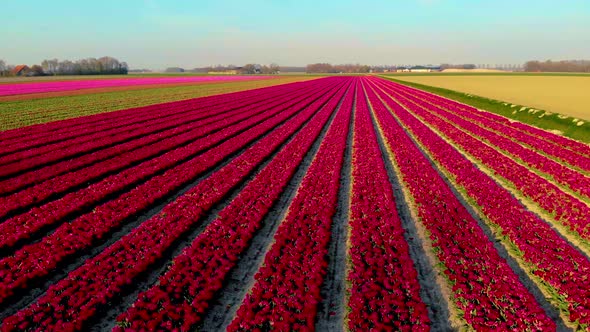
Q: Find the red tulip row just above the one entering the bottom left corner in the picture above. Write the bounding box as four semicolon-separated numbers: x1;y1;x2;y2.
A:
0;78;346;308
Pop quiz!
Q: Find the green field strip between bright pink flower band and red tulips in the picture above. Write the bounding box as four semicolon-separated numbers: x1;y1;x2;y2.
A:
0;76;316;131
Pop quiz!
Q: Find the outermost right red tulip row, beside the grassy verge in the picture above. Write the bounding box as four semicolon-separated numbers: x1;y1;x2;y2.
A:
387;82;590;161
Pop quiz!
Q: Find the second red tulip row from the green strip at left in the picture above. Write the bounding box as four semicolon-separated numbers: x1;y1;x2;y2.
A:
0;81;320;176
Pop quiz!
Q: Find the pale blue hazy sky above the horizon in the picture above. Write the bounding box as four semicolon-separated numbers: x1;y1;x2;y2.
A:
0;0;590;69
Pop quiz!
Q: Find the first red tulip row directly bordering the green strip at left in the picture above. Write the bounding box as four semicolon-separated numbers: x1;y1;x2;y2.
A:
0;81;311;147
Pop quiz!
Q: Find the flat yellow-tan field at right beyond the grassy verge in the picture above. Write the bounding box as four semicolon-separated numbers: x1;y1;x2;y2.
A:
395;75;590;120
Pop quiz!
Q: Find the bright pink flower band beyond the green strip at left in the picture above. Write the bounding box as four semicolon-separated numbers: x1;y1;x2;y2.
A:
0;76;272;96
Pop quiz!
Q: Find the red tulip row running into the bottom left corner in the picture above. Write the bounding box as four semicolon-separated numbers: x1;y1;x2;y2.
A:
2;76;352;331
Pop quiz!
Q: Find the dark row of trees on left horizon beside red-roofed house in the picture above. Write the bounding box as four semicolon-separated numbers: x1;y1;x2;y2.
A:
0;56;128;76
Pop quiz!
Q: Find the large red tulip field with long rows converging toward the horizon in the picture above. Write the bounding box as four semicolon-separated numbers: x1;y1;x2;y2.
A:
0;76;590;331
